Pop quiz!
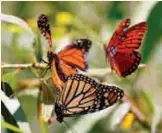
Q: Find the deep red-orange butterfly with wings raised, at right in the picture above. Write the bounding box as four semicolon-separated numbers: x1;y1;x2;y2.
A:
105;19;147;77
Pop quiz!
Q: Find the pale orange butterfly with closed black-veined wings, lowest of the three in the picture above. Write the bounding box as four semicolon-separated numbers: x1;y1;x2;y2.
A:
55;74;124;123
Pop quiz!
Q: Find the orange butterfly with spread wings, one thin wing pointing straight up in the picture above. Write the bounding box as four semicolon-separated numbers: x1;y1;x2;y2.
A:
37;14;92;92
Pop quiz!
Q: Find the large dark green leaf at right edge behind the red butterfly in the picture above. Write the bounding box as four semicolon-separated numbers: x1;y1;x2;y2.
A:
142;2;162;63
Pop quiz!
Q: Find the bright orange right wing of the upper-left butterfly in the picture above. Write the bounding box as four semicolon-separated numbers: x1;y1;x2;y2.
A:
58;39;92;75
